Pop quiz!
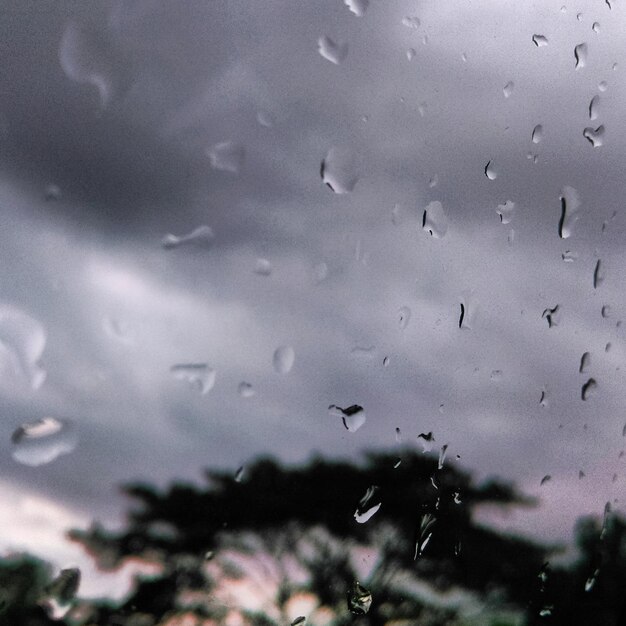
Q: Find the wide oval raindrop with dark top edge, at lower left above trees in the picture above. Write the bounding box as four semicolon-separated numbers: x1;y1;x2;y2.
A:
11;417;78;467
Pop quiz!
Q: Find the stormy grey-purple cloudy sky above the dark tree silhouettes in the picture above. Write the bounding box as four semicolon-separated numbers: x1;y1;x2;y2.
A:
0;0;626;588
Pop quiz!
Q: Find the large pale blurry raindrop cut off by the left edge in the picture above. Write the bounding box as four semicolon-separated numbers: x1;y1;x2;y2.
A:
0;305;46;389
